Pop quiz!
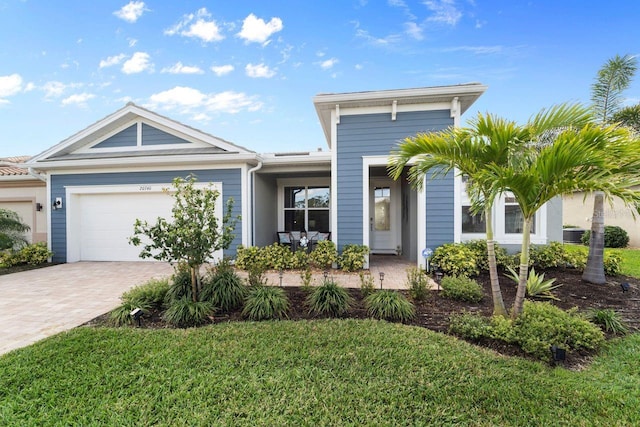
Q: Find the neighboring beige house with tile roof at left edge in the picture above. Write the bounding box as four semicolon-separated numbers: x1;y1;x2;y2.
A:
0;156;47;243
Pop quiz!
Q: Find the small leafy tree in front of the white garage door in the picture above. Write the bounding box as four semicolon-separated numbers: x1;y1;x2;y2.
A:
129;175;239;302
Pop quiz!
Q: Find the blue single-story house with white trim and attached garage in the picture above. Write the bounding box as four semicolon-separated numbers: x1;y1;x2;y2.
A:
26;83;562;263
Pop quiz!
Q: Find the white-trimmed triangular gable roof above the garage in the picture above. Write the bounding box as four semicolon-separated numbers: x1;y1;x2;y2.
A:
28;102;255;167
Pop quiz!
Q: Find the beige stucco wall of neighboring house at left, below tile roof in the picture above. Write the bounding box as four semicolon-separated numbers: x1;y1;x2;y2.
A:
0;180;47;243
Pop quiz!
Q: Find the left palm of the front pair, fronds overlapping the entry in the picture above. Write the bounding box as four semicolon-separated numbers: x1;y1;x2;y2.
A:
389;106;589;316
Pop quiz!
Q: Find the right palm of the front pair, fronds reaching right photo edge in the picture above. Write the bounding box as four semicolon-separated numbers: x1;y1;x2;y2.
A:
483;122;640;318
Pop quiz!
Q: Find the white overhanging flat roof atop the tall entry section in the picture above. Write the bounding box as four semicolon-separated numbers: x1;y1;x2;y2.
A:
313;83;487;146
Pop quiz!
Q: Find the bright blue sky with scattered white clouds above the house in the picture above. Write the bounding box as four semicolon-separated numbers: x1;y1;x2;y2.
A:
0;0;640;157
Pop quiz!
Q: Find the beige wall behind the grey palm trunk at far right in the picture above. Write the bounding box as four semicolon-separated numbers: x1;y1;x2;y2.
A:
562;187;640;248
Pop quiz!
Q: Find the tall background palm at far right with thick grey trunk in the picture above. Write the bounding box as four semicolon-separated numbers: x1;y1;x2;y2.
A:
582;55;637;284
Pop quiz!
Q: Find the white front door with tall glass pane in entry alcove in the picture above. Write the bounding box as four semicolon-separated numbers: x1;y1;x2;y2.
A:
369;179;400;254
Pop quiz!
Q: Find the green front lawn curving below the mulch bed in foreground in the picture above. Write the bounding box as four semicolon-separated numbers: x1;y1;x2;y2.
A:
0;320;640;426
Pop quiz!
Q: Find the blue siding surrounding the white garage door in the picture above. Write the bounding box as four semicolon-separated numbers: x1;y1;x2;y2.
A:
51;169;243;262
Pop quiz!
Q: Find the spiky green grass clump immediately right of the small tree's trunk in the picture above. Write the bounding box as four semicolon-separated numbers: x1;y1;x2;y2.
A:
200;260;247;311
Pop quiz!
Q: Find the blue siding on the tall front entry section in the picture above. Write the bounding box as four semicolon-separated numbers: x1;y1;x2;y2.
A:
336;110;453;250
